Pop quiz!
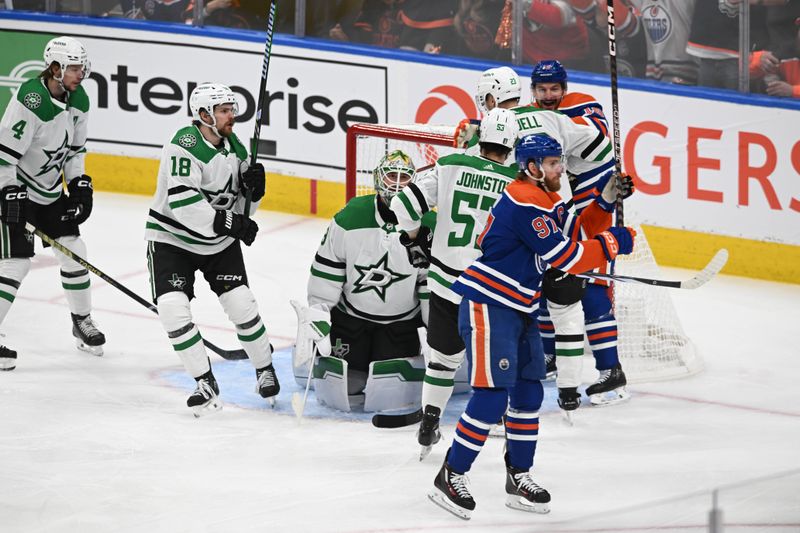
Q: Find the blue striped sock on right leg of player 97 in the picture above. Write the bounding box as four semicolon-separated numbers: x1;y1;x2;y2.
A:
506;380;544;471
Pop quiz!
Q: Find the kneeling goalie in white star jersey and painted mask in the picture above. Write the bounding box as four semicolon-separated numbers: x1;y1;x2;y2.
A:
295;150;433;411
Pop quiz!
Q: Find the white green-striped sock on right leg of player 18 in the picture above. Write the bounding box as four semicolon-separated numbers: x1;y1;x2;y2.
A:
219;285;272;369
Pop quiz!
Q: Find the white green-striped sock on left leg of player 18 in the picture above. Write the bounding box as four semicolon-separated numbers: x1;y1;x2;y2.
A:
158;291;211;379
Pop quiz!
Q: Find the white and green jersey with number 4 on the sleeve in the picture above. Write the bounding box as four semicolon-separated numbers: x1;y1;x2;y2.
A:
0;78;89;205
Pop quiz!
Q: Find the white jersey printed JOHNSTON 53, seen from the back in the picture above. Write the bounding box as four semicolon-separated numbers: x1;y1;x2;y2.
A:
391;154;517;304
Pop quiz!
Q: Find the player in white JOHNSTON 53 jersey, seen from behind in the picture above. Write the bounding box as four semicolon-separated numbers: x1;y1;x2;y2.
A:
392;108;517;458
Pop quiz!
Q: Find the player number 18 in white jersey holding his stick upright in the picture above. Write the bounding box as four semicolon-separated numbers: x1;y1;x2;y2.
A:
145;83;280;416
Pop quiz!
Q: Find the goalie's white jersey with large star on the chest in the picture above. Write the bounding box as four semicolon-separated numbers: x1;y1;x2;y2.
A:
308;194;429;324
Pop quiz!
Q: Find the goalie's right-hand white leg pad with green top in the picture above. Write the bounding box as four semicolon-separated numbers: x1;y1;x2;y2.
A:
364;357;425;411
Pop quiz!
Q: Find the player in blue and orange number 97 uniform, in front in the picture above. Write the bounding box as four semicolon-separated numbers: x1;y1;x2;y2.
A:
429;135;635;519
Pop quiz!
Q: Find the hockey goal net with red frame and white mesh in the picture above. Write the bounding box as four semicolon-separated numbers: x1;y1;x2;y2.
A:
346;124;703;382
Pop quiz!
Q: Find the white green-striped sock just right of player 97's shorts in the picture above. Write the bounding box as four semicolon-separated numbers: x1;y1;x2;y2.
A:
547;301;584;388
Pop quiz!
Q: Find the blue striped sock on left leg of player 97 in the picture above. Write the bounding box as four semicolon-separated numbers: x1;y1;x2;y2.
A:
447;388;508;474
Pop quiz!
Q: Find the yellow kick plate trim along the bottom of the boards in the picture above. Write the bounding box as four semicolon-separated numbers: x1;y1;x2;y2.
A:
86;154;800;284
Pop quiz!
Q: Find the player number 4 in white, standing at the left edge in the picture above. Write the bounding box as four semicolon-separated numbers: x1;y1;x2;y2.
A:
0;37;105;370
